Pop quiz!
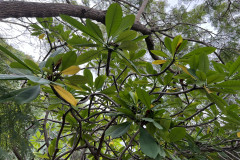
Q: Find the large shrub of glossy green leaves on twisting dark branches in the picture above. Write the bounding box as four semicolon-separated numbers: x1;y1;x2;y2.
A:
0;3;240;160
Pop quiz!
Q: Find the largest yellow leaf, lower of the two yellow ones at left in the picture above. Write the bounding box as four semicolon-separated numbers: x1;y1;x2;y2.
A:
52;85;77;106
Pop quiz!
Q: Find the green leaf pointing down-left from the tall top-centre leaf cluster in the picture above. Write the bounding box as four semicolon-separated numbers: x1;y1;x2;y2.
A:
76;50;100;65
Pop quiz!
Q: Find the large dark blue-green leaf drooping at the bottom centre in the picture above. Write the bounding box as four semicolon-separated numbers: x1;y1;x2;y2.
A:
139;127;160;158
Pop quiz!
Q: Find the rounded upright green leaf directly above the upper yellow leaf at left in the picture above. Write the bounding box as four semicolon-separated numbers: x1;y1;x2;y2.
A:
61;51;77;71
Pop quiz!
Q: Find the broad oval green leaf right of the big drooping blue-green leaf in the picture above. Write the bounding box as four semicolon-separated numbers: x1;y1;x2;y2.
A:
169;127;186;142
